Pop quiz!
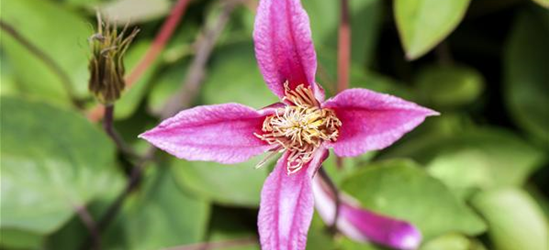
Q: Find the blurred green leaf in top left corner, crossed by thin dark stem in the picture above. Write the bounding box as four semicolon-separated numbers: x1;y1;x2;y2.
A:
2;0;93;104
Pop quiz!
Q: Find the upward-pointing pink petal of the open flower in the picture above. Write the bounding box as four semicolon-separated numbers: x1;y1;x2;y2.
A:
254;0;324;101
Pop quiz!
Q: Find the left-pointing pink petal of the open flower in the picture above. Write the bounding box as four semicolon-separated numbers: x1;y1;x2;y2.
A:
139;103;272;164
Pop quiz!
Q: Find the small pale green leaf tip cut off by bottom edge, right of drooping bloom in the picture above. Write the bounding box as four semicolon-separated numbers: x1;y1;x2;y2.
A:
420;233;486;250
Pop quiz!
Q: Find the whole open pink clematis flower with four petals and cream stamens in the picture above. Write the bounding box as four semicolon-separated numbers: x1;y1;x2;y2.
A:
140;0;437;250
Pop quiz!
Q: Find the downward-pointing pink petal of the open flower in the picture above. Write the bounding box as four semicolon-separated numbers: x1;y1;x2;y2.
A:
257;148;328;250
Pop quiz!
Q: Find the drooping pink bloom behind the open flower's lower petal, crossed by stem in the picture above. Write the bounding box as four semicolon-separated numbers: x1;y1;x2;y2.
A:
313;176;422;250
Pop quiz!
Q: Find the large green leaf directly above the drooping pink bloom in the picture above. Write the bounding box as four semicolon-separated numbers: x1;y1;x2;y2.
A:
343;160;486;240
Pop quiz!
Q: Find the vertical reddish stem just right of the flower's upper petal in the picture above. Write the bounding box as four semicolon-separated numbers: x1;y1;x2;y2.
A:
337;0;351;92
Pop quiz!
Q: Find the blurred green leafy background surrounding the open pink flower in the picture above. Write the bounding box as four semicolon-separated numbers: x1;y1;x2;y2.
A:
0;0;549;250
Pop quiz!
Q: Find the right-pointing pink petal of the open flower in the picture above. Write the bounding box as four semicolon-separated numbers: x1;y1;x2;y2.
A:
323;89;438;157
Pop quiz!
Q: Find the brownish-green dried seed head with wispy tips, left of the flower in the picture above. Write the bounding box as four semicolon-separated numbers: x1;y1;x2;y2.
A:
88;13;139;105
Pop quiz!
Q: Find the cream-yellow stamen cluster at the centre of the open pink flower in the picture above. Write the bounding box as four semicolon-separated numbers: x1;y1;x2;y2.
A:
255;82;341;174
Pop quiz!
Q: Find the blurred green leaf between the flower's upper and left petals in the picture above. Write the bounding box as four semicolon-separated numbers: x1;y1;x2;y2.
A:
202;42;278;108
